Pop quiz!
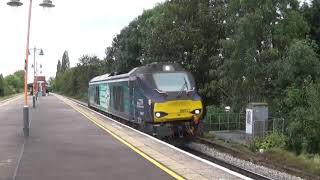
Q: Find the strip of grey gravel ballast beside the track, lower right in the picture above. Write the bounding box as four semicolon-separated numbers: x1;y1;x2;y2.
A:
186;142;302;180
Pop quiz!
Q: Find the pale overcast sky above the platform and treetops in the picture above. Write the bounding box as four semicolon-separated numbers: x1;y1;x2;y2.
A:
0;0;164;82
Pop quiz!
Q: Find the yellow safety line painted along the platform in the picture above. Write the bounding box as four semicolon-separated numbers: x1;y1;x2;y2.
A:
58;97;185;180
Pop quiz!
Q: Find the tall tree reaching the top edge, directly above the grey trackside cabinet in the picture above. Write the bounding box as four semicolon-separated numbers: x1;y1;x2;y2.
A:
219;0;309;110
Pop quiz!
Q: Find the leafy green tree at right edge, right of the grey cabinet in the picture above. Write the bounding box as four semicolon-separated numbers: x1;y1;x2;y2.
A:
277;40;320;153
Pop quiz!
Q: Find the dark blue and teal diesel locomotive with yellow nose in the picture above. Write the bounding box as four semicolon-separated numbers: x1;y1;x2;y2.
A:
88;63;203;138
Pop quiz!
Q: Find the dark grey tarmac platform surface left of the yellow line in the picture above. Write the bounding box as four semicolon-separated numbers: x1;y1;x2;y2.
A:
0;96;173;180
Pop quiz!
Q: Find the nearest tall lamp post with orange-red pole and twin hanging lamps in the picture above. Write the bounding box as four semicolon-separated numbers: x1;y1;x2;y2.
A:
7;0;54;137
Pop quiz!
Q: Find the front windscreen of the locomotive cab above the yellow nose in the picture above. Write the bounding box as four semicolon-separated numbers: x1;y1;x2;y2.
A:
152;72;191;92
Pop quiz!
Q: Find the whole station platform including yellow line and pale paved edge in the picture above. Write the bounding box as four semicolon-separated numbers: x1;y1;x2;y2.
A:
0;94;248;180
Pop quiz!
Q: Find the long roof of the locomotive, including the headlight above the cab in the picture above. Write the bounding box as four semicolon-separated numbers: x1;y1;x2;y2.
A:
89;63;185;83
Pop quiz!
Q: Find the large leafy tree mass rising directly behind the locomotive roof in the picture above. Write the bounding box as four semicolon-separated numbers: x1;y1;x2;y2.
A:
106;0;226;106
